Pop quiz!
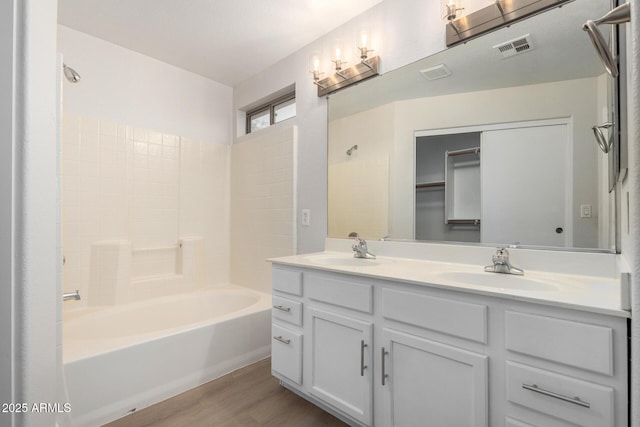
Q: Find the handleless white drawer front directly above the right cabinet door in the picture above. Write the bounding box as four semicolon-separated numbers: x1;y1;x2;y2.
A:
382;289;487;344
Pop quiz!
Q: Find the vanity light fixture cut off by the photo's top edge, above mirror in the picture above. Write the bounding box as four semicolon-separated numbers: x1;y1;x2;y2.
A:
445;0;573;47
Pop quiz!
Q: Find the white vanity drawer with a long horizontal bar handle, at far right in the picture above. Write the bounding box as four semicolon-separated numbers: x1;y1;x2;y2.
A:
507;361;614;427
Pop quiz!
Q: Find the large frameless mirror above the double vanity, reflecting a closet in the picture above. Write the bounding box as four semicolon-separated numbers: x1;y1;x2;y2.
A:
328;0;616;251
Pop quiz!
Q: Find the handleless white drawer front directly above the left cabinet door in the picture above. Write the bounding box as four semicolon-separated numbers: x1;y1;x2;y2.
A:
305;274;373;313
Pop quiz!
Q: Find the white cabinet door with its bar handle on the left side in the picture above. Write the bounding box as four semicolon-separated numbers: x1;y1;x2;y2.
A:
379;329;488;427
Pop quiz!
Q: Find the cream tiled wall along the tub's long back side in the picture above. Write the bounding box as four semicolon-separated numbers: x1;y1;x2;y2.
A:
62;114;230;301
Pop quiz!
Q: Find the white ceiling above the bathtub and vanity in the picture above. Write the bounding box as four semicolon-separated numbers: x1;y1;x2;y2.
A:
58;0;382;86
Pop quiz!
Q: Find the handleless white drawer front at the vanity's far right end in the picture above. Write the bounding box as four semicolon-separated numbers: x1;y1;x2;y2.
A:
505;311;613;376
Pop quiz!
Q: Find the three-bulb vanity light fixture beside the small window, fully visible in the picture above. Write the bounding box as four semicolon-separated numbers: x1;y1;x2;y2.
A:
309;32;380;96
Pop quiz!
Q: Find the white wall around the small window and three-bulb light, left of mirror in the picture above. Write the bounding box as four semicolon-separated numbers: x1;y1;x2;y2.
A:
233;0;445;253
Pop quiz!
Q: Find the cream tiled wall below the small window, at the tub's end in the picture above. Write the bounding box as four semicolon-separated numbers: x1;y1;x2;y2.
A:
231;126;297;293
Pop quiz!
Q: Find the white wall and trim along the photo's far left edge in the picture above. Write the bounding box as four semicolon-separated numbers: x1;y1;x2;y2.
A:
0;0;59;426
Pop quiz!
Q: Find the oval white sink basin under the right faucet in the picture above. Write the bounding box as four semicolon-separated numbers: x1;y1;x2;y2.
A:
438;271;558;291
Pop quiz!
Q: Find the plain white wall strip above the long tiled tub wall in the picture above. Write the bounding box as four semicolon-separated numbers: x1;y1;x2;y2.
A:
58;25;232;144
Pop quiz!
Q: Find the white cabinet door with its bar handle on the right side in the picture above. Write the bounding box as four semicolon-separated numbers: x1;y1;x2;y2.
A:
309;308;373;425
